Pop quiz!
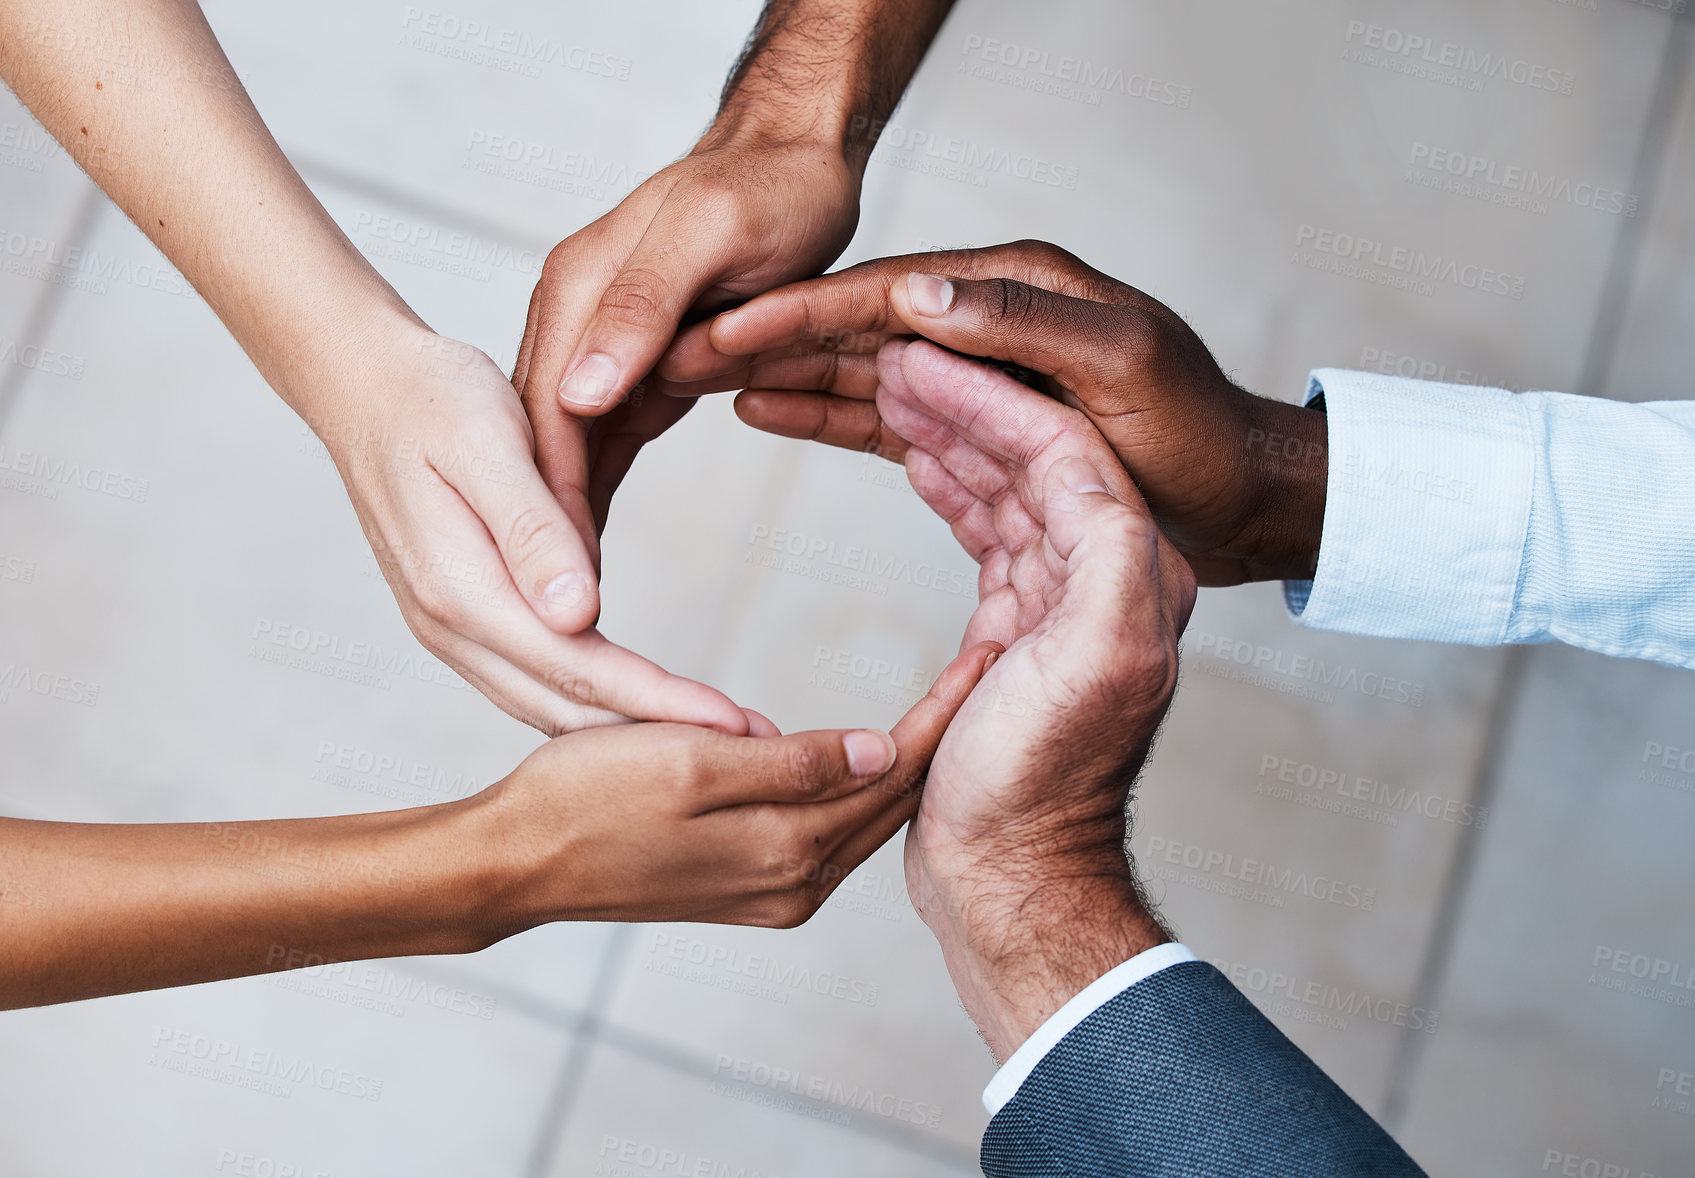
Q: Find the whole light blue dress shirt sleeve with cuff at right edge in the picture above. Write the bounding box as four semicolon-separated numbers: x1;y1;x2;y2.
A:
1285;368;1695;668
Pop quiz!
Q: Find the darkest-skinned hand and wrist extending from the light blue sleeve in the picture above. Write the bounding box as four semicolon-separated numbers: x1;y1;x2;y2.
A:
659;241;1327;585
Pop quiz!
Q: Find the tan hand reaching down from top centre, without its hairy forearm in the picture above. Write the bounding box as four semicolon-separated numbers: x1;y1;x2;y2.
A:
512;136;859;522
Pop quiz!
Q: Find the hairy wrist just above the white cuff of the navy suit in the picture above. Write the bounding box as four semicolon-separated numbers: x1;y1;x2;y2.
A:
924;863;1171;1063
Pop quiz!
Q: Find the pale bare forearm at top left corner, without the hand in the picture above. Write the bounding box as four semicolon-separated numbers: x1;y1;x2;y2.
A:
0;0;422;412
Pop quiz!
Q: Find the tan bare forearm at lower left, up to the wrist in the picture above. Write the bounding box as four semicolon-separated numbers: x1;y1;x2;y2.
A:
0;800;517;1009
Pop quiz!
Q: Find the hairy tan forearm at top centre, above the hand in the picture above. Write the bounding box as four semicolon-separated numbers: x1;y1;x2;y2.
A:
709;0;954;169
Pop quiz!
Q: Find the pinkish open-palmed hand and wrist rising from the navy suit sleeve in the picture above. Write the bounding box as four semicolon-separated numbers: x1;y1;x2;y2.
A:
876;342;1195;1059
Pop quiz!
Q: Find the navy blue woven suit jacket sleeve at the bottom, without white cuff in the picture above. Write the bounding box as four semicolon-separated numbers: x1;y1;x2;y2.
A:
983;961;1424;1178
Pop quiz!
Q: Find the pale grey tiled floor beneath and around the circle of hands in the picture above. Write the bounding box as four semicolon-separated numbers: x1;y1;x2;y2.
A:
0;0;1695;1178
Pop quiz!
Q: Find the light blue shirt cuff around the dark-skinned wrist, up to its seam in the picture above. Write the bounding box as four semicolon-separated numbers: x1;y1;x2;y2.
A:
1285;368;1536;646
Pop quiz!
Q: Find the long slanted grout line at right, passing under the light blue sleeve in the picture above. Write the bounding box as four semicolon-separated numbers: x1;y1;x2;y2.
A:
1383;6;1695;1134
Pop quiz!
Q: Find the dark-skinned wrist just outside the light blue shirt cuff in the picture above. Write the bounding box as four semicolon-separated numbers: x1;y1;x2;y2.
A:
1244;397;1331;581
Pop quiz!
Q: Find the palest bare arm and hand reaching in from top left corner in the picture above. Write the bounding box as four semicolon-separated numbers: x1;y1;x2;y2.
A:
0;0;747;734
